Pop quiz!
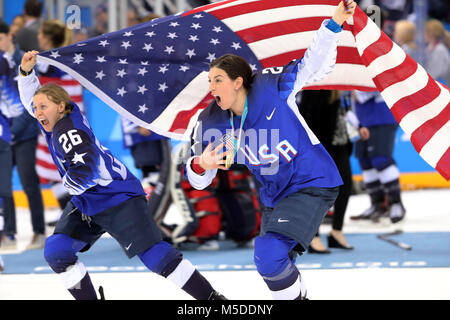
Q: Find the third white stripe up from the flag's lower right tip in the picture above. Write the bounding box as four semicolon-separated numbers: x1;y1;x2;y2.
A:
380;64;428;108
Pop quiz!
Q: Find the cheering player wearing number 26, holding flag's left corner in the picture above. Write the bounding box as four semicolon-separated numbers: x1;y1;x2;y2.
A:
18;51;224;300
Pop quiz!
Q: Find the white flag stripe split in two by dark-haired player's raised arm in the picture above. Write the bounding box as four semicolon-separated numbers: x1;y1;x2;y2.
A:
248;30;356;59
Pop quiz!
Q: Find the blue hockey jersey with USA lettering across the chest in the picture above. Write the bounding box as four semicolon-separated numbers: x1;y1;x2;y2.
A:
186;22;342;207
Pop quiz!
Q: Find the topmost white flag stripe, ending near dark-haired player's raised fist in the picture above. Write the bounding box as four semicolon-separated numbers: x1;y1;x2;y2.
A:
220;5;336;32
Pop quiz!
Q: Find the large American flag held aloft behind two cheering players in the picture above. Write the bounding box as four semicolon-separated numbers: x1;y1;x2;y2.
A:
38;0;450;179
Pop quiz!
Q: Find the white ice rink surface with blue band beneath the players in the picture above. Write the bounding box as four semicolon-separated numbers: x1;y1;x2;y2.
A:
0;189;450;301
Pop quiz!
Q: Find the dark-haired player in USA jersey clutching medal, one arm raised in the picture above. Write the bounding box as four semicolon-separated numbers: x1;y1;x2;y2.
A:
186;0;356;300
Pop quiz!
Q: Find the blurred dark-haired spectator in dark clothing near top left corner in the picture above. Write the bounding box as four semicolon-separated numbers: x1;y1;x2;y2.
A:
15;0;42;51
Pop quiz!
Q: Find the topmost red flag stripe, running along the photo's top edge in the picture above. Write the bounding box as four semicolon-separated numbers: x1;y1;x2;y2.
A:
210;0;340;20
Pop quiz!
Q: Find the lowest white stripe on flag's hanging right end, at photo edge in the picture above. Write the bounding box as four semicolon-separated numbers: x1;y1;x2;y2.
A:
419;121;450;168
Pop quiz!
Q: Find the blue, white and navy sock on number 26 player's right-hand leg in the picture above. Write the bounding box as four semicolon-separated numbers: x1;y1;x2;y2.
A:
138;241;214;300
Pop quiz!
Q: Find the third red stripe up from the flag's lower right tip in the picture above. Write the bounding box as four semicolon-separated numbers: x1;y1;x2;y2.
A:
391;76;441;123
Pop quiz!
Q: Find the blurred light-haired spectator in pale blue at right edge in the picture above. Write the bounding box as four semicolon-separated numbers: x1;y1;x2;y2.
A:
425;19;450;84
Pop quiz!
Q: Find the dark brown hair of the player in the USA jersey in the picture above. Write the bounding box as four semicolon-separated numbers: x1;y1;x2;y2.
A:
209;54;253;90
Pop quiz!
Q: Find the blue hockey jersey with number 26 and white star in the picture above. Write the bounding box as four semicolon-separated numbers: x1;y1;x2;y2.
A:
19;72;145;216
